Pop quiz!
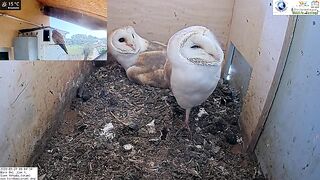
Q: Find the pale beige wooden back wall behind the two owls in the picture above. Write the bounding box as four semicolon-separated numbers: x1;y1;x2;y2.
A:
108;0;234;50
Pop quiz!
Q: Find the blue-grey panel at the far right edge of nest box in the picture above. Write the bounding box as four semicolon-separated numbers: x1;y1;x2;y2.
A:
255;16;320;180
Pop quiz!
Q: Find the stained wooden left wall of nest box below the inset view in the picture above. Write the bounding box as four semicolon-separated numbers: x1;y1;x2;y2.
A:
0;61;91;166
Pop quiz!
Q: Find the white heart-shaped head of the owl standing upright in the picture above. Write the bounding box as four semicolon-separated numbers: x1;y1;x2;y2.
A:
167;26;224;66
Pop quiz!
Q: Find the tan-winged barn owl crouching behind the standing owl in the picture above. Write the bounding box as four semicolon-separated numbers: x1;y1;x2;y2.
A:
108;26;169;88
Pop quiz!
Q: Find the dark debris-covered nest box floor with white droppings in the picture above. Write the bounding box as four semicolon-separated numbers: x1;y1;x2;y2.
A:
34;58;264;179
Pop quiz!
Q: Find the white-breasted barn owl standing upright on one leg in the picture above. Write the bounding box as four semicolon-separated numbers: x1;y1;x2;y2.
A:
167;26;224;131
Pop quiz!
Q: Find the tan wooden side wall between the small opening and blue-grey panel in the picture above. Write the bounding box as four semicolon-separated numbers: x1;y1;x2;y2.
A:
230;0;293;150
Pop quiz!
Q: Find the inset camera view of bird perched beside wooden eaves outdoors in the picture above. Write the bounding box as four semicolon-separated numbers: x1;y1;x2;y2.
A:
0;0;107;61
